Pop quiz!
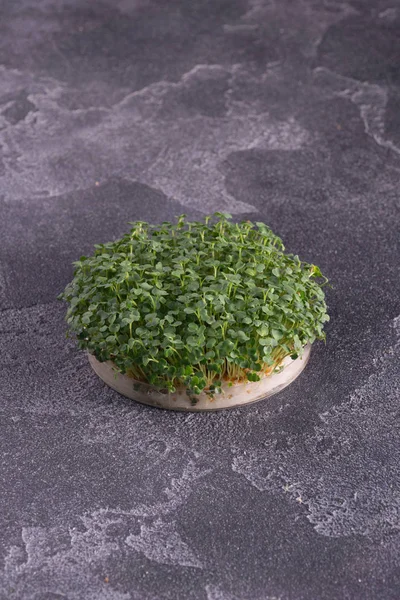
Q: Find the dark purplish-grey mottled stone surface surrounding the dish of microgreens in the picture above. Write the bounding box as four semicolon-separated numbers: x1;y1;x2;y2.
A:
0;0;400;600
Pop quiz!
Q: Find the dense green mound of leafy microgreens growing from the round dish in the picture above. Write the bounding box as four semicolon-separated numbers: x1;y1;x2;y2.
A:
60;213;329;396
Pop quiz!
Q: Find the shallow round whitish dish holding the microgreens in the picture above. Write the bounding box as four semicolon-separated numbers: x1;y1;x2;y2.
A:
89;344;311;412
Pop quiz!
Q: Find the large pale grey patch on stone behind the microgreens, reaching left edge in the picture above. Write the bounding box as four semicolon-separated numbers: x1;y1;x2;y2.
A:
0;65;308;214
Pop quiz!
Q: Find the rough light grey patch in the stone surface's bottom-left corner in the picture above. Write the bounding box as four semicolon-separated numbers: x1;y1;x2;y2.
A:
2;463;207;600
